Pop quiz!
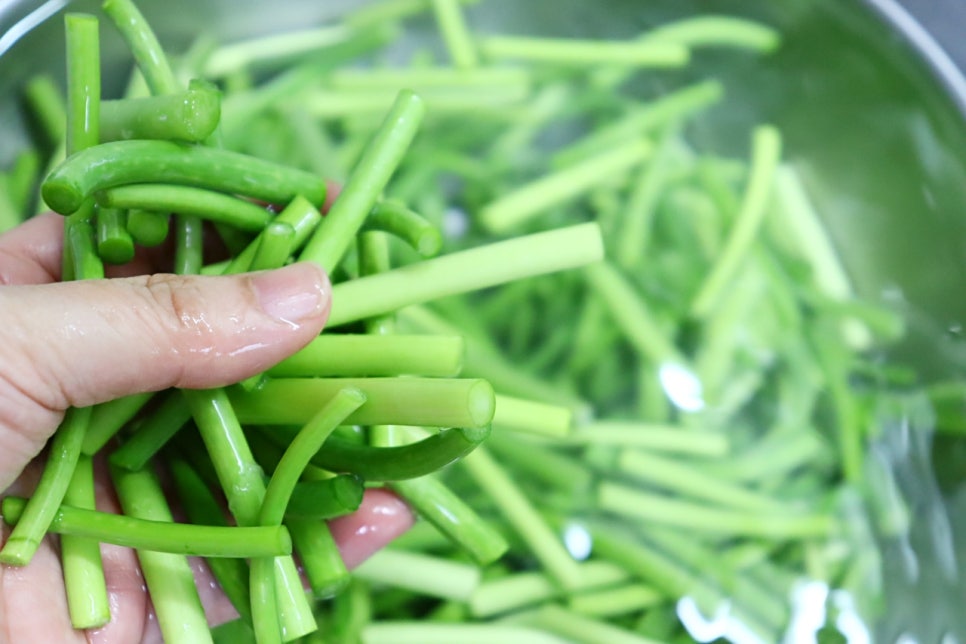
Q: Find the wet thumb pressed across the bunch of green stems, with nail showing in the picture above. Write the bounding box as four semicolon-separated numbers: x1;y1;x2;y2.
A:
0;263;331;449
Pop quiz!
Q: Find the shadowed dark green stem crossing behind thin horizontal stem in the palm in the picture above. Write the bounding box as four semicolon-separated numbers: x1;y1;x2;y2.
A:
167;459;253;624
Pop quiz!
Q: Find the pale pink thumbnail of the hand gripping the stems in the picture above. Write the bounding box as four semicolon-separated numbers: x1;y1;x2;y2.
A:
252;262;330;324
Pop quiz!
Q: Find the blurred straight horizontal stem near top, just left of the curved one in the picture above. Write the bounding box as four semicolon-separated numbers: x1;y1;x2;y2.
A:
480;36;690;67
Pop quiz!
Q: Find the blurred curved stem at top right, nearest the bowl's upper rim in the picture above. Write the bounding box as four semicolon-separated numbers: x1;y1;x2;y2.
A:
642;15;781;53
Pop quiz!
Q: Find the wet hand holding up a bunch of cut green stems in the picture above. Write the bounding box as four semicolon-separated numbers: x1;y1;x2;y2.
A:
0;214;412;644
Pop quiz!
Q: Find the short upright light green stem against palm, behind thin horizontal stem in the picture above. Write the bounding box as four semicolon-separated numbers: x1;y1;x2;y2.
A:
59;455;111;629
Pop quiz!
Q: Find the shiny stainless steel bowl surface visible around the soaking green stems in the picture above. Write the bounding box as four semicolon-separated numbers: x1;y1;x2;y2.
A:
0;0;966;642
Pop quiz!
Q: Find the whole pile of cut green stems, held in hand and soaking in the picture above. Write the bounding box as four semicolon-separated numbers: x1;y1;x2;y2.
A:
0;0;942;644
